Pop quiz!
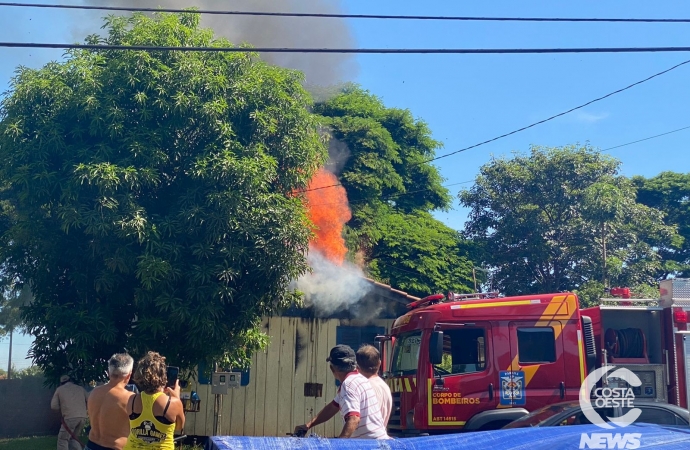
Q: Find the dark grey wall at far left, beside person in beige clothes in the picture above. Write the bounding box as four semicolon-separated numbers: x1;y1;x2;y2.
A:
0;377;60;438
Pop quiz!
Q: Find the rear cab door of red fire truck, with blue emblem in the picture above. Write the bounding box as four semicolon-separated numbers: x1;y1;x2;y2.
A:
506;320;566;411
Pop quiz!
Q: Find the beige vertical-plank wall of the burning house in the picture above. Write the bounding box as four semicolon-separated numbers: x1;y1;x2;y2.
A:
184;317;393;437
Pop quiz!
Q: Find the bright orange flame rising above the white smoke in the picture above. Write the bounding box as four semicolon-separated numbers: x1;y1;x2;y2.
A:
307;168;352;265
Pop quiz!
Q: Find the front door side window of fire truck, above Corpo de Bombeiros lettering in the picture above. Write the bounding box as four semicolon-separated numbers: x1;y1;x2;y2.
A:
435;328;486;375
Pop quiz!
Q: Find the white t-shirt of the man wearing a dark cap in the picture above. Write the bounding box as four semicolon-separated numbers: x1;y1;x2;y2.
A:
333;372;390;439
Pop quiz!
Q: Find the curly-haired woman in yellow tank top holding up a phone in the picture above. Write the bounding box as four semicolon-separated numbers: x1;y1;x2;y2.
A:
123;352;185;450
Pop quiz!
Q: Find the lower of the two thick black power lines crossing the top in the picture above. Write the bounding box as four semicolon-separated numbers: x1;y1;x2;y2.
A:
5;42;690;55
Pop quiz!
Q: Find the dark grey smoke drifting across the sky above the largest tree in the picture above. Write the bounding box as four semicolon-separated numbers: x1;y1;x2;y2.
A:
74;0;358;86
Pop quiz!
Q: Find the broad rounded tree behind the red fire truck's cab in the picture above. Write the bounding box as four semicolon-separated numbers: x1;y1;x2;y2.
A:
459;146;676;308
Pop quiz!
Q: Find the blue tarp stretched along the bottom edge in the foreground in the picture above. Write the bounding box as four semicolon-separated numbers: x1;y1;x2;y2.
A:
206;424;690;450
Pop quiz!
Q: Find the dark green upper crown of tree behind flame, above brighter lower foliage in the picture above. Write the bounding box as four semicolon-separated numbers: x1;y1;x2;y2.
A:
314;86;452;219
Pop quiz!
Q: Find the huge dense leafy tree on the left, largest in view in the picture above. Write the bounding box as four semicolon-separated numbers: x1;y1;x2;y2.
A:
0;13;327;382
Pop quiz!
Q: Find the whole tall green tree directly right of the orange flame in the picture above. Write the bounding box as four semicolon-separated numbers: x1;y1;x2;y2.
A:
314;84;472;295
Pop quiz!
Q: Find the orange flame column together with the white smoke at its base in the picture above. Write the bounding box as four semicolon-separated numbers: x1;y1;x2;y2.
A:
293;169;373;317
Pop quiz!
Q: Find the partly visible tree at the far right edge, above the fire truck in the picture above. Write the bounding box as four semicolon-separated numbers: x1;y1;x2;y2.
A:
632;172;690;280
